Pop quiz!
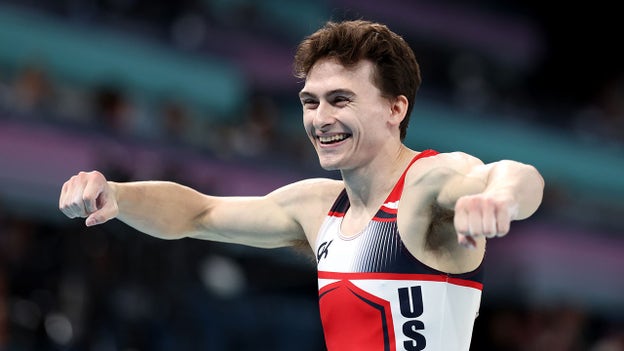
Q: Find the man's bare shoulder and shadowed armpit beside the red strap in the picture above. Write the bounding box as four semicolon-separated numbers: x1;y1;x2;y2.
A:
398;152;485;273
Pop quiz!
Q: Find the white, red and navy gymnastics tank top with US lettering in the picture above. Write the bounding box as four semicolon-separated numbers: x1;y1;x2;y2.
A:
316;150;483;351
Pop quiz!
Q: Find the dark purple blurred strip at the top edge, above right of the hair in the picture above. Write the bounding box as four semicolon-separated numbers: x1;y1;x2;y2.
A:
335;0;543;67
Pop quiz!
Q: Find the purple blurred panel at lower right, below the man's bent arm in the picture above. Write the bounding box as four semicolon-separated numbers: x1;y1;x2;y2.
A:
486;222;624;311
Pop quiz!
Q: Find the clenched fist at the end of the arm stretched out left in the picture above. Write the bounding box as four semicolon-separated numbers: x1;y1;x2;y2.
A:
59;171;119;227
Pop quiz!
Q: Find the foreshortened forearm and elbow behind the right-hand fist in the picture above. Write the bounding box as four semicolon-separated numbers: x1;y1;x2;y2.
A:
484;160;544;220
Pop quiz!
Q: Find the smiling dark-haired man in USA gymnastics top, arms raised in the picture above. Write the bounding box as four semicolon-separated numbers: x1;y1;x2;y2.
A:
59;21;544;351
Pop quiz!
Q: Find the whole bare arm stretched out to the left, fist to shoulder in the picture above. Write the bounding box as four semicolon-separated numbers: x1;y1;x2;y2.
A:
59;171;337;248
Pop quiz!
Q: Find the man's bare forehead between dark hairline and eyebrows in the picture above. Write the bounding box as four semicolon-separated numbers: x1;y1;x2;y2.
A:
302;58;376;94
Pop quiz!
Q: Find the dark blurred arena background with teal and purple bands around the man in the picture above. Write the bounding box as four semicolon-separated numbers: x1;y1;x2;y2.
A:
0;0;624;351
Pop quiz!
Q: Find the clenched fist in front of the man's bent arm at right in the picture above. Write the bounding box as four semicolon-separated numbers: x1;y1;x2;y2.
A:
454;193;518;248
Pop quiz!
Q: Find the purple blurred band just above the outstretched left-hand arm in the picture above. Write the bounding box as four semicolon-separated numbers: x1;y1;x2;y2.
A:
0;119;301;211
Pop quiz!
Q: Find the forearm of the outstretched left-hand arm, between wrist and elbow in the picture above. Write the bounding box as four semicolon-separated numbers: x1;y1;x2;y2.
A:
109;181;206;239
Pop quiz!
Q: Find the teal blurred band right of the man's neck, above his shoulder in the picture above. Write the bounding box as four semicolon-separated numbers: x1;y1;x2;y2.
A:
406;100;624;207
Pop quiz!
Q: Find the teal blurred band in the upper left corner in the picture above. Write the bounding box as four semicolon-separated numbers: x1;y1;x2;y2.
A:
0;5;247;115
